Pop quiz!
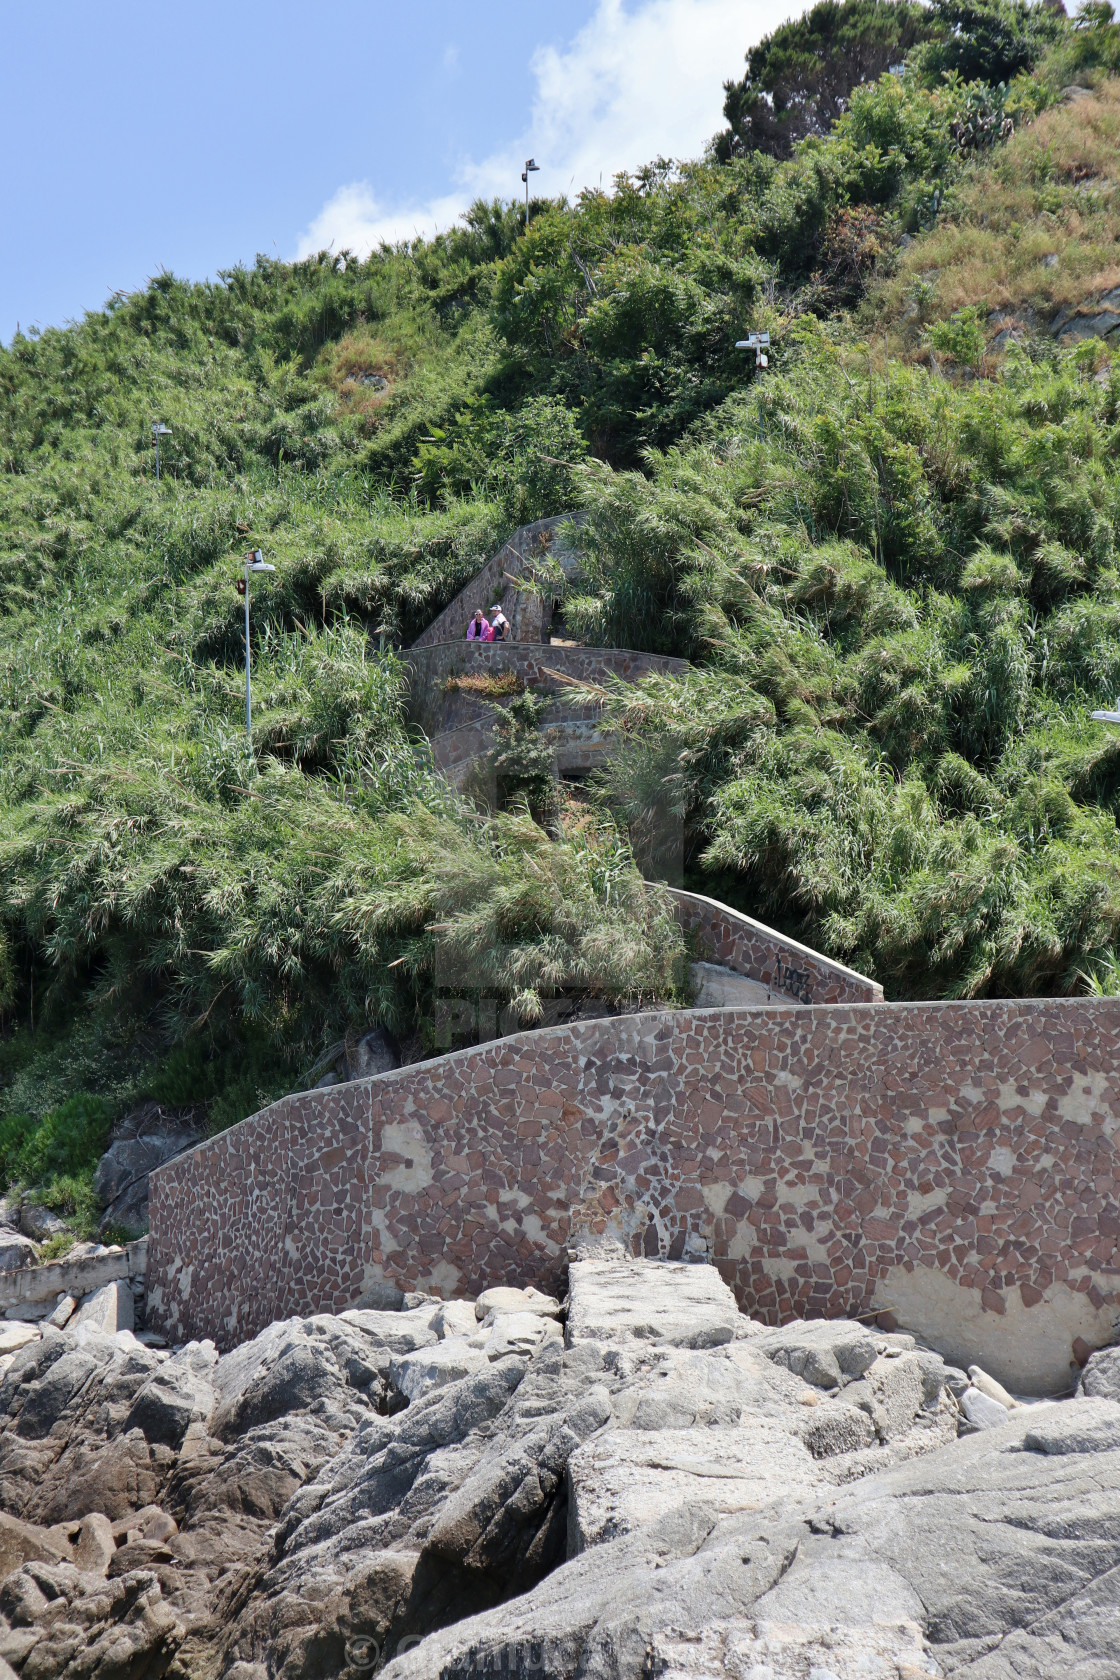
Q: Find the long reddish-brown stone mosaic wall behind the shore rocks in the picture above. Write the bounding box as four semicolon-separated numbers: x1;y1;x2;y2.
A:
148;1000;1120;1393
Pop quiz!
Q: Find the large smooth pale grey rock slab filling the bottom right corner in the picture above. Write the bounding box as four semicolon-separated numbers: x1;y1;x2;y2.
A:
385;1401;1120;1680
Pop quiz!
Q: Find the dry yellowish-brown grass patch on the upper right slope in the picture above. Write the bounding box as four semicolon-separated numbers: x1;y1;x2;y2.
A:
870;77;1120;353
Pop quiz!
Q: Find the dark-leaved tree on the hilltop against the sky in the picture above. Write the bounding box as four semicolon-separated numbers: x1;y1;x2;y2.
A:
715;0;930;161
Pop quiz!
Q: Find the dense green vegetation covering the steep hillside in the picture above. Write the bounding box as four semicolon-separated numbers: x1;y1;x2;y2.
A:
0;0;1120;1236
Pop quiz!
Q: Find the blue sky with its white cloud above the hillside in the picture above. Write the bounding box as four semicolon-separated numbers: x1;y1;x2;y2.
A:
0;0;796;343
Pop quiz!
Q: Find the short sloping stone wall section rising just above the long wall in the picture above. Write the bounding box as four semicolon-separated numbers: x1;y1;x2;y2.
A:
670;889;883;1003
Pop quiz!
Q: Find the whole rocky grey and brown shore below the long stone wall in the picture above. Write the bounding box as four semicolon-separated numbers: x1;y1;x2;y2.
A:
0;1248;1120;1680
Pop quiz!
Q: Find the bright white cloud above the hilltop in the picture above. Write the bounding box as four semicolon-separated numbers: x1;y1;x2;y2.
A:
299;0;798;257
